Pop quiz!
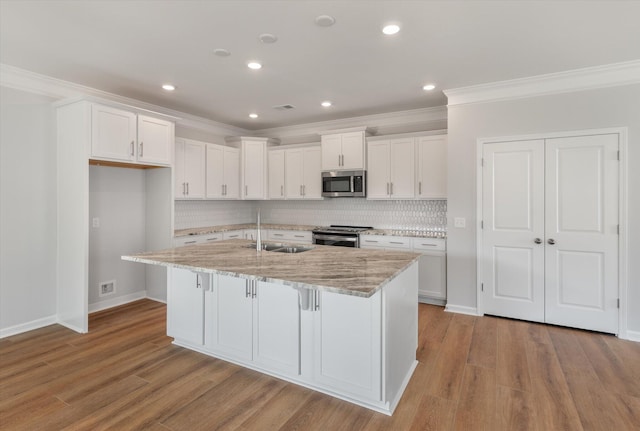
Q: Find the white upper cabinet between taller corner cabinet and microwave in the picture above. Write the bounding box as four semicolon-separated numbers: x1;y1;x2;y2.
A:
285;147;322;199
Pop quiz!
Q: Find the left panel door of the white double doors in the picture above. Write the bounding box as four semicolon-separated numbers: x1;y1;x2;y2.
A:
482;140;544;322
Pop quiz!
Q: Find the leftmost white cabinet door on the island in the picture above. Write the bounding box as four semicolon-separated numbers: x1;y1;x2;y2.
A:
167;268;208;345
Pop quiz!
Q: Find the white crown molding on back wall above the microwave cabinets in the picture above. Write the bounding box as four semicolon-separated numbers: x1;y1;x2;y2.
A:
251;106;447;144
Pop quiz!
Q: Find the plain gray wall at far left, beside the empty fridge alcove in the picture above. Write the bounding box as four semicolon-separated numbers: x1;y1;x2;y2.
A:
0;87;56;331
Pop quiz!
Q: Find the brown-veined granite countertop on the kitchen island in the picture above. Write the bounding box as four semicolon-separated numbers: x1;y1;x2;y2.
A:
122;239;420;297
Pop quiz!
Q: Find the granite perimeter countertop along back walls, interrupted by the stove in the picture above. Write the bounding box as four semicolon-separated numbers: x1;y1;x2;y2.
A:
173;223;447;239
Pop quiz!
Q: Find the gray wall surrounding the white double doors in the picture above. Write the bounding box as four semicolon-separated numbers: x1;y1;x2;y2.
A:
447;85;640;331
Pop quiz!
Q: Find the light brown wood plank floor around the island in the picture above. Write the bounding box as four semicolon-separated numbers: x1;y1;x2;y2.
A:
0;300;640;431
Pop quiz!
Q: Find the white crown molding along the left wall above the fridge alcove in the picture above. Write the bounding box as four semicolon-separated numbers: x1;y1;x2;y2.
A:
0;63;250;136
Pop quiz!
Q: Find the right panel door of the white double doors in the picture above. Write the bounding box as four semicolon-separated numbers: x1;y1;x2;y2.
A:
545;135;619;333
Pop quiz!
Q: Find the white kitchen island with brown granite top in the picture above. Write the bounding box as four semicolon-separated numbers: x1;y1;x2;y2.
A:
123;240;419;414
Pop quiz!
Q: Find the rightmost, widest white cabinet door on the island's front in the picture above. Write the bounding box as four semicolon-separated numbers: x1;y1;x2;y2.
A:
313;291;382;401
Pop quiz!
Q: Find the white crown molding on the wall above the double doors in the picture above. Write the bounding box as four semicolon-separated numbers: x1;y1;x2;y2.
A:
444;60;640;106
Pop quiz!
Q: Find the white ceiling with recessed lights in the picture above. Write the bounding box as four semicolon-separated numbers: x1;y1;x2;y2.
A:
0;0;640;130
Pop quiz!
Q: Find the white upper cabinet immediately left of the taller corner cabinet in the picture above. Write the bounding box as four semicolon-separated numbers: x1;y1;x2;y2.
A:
206;144;240;199
